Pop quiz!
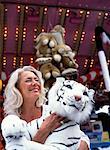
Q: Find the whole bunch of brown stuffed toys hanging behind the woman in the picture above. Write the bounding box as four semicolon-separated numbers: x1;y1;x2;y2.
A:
35;25;78;90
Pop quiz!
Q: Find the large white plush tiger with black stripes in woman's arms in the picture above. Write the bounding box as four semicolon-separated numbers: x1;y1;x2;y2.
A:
1;78;94;150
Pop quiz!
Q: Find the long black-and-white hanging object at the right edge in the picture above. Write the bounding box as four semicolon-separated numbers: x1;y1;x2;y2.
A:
95;26;110;92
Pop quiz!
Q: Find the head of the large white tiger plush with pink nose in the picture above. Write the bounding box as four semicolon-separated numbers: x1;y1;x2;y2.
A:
48;77;95;123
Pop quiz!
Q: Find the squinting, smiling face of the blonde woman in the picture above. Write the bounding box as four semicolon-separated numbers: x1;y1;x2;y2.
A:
18;71;41;100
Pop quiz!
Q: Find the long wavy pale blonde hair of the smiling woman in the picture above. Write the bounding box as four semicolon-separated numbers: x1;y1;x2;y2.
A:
3;66;46;116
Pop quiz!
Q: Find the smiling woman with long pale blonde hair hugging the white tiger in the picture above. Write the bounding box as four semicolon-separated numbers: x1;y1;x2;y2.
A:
4;66;88;150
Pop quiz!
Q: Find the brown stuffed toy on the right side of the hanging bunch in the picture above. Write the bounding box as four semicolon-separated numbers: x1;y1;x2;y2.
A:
52;44;78;75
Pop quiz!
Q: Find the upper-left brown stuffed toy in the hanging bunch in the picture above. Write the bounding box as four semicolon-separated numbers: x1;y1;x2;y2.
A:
35;33;57;64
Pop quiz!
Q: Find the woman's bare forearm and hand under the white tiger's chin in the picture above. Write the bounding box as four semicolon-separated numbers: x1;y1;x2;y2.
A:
33;113;65;144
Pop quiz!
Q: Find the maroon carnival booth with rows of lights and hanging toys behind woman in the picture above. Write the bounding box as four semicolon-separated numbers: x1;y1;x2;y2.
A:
0;0;110;150
